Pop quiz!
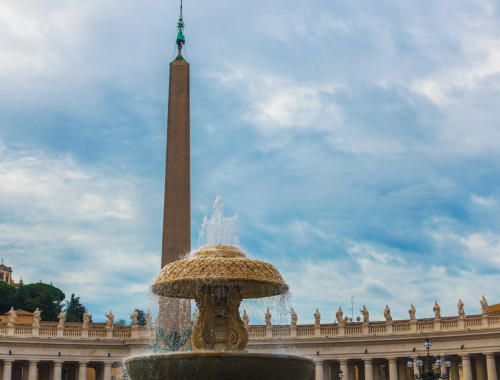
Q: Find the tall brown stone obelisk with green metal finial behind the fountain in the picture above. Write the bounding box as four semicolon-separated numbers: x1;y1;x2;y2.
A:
160;1;191;331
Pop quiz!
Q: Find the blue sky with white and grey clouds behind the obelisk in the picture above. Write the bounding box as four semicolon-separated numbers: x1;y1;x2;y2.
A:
0;0;500;323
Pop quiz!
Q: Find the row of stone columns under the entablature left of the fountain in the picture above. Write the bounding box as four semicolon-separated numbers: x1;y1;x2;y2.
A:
0;357;118;380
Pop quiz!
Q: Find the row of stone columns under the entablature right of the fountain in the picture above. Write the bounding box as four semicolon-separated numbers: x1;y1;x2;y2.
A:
314;353;500;380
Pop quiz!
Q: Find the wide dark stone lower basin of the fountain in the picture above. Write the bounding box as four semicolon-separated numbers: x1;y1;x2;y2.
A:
125;351;314;380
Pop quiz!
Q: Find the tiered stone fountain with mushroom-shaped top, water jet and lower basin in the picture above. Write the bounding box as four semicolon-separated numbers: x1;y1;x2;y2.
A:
125;197;314;380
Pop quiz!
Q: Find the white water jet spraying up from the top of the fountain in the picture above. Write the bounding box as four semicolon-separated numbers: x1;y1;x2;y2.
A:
200;195;240;245
